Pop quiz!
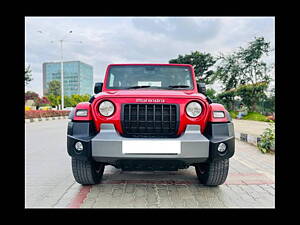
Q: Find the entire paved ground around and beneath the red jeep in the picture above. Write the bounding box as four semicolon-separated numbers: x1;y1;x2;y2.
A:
25;120;275;208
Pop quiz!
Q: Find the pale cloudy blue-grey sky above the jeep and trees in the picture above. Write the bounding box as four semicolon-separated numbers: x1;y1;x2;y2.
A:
25;17;275;96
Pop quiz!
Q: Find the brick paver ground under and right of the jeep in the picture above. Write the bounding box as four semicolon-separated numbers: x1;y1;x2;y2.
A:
80;140;275;208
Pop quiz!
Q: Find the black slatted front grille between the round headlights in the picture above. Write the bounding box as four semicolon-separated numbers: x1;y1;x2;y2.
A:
121;104;179;137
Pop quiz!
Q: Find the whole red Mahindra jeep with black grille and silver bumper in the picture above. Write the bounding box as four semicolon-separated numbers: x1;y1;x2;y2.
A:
67;64;235;186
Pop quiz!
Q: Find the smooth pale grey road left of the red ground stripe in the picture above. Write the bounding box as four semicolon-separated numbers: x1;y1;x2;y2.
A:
25;119;81;208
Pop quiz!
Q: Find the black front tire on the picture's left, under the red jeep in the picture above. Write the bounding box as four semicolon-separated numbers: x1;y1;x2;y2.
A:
72;157;105;185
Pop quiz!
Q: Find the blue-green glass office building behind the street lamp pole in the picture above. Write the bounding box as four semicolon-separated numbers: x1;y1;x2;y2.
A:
43;61;94;96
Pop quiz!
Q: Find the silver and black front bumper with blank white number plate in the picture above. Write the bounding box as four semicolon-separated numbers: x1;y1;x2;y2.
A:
67;122;234;168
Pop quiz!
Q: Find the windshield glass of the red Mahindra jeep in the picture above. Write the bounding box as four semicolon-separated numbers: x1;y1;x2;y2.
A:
106;65;193;90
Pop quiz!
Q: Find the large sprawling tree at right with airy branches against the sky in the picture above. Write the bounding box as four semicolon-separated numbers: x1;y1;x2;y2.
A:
213;37;271;111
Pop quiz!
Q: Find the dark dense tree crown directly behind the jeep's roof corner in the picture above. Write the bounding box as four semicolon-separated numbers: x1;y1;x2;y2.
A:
169;51;216;84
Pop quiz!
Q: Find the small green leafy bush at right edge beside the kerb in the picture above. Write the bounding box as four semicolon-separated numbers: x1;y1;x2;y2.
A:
257;123;275;153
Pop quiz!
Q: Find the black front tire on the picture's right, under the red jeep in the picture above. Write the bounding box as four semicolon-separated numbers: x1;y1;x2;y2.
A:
195;159;229;186
